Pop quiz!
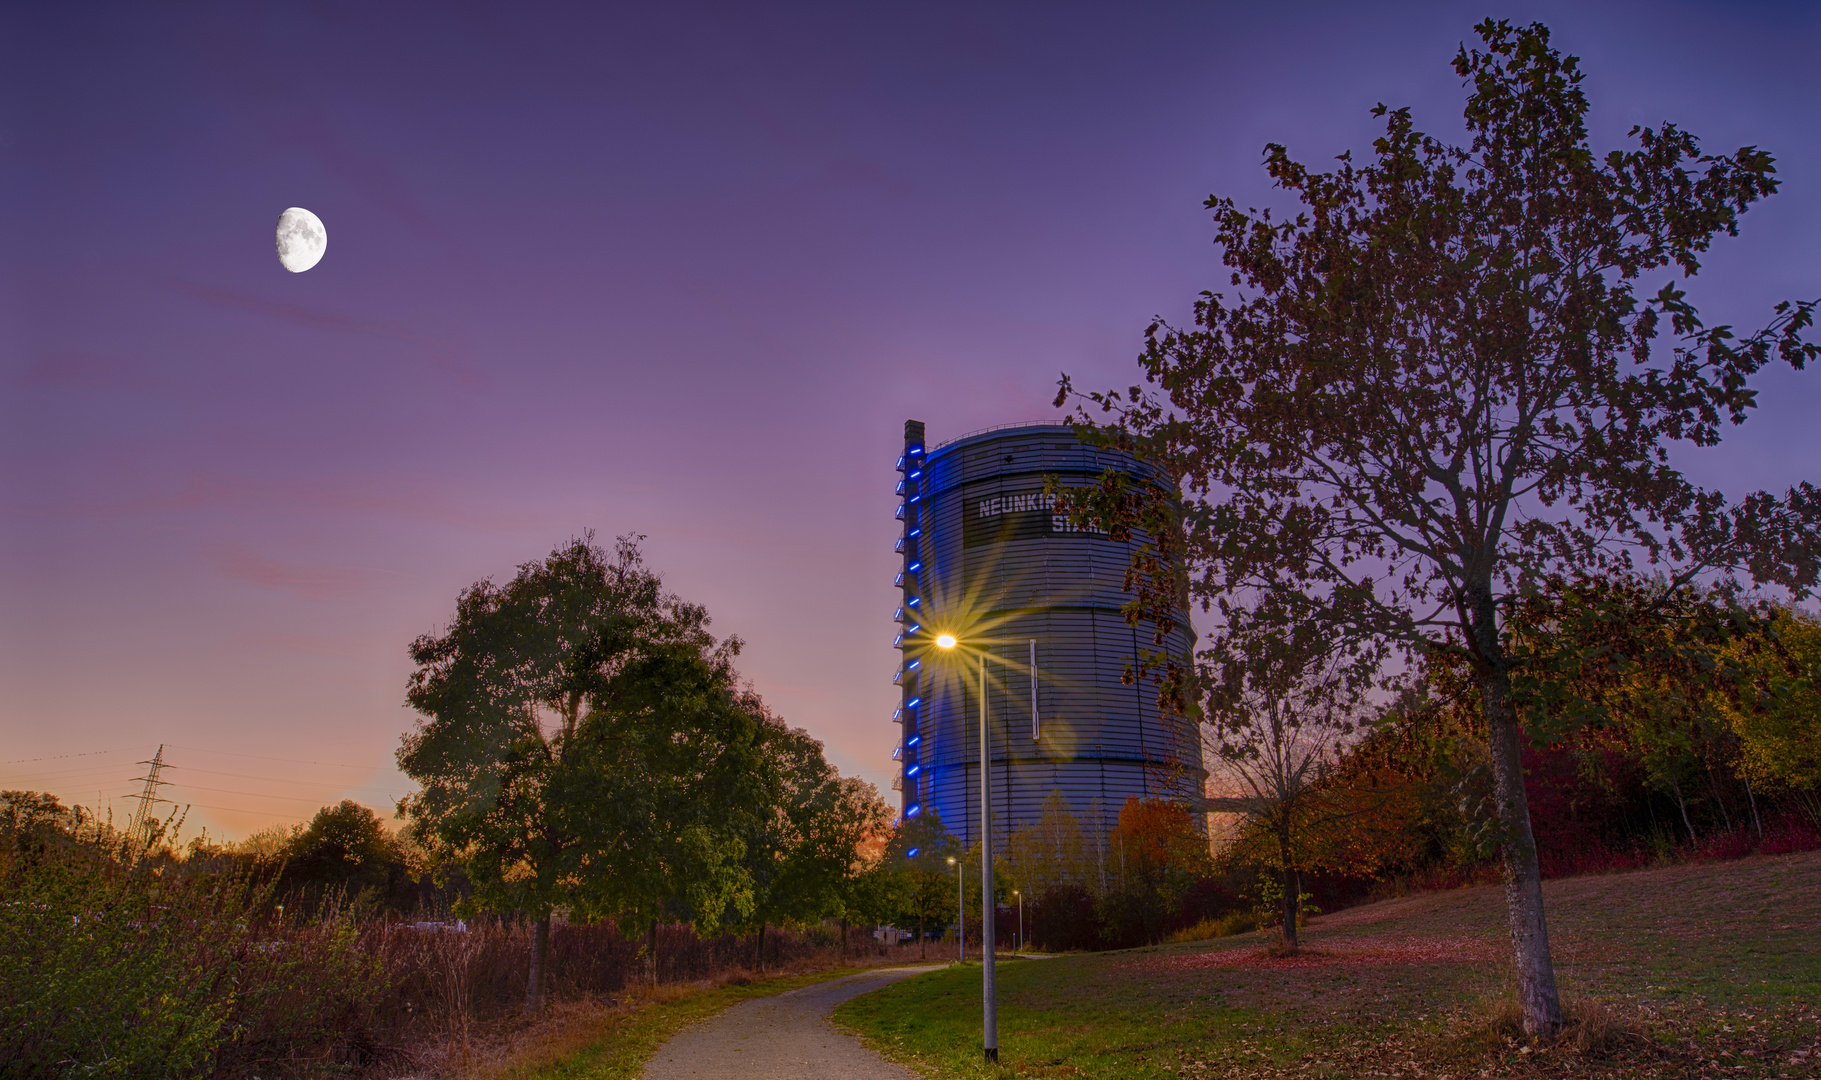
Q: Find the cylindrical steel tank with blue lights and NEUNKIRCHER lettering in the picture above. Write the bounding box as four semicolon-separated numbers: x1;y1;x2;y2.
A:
896;421;1206;843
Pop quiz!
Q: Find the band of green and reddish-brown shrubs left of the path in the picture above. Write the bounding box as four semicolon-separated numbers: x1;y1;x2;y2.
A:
0;851;910;1078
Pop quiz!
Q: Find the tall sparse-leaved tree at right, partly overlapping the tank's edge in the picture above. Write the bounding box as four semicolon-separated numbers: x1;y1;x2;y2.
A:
1058;20;1821;1034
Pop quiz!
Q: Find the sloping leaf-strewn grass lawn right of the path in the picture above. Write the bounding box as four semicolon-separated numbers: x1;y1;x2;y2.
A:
836;852;1821;1078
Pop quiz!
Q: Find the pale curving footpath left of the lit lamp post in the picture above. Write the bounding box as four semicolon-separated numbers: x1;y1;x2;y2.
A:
645;963;940;1080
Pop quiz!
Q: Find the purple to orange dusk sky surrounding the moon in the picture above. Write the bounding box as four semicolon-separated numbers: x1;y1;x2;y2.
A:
0;2;1821;836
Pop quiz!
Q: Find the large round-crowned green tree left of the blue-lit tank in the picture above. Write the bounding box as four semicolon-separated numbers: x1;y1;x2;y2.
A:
399;535;752;1011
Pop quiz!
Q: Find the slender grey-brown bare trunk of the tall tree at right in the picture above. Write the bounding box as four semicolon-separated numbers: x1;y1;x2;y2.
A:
1475;637;1562;1036
